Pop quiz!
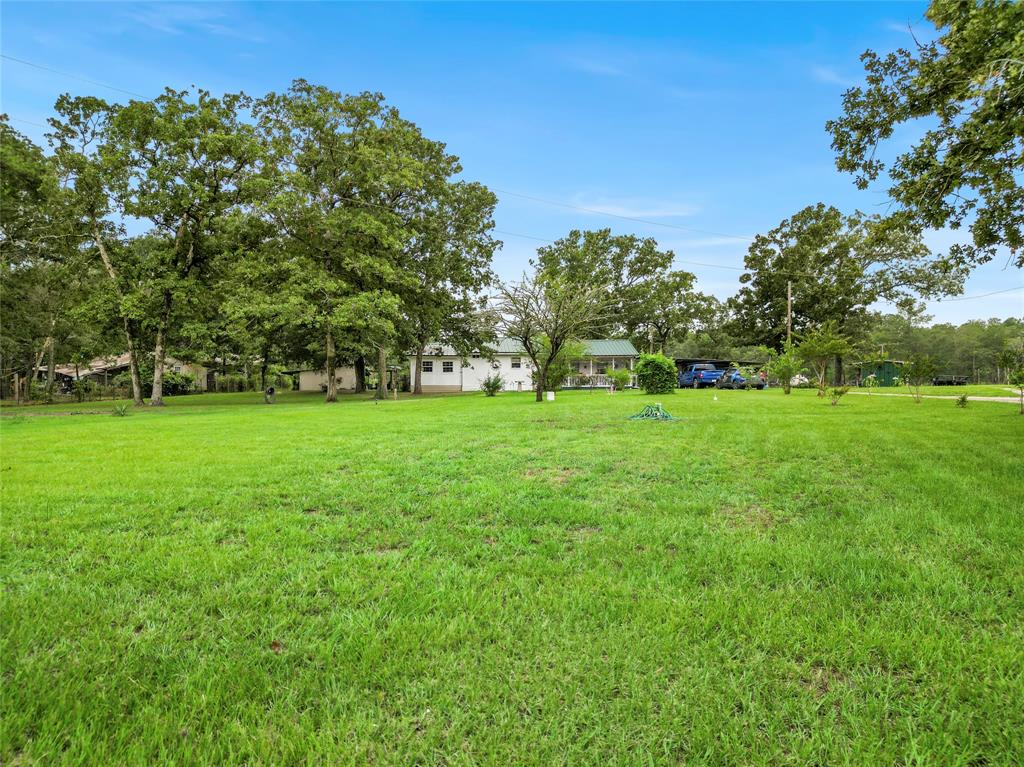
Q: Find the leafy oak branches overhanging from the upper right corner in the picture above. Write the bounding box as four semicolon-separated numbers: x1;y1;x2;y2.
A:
825;0;1024;267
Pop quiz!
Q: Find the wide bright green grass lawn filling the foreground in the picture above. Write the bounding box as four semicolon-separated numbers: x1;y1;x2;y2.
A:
0;391;1024;766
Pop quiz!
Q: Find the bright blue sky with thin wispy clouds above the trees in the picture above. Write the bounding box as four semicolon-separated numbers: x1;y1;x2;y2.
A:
0;2;1024;322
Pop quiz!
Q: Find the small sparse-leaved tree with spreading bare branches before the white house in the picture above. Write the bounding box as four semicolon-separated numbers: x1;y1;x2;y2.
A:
496;271;605;402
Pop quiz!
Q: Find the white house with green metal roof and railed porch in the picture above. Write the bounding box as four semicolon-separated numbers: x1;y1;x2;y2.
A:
409;338;639;392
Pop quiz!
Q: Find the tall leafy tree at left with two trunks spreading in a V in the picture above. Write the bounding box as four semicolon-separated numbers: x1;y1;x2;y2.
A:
50;88;263;406
